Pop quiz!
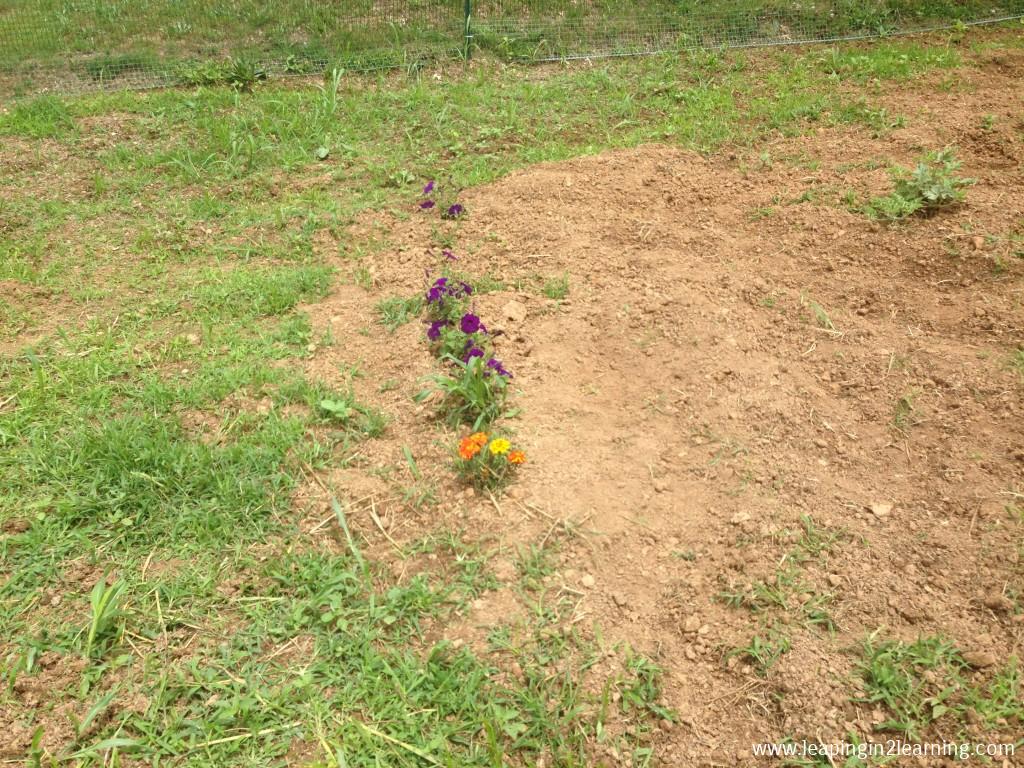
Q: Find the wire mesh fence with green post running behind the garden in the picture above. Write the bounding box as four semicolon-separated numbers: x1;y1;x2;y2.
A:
0;0;1024;92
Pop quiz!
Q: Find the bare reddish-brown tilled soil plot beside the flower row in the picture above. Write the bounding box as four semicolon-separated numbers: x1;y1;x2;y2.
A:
297;53;1024;765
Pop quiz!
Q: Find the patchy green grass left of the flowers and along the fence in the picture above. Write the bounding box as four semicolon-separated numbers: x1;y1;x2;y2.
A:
0;28;1007;766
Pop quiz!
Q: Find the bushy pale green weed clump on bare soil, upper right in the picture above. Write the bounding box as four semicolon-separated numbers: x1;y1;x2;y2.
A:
863;147;974;221
